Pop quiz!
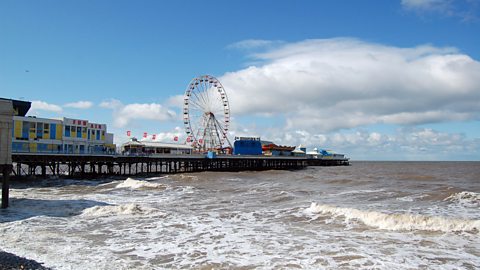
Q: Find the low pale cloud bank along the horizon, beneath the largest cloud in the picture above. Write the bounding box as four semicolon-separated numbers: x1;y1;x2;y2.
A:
238;123;480;160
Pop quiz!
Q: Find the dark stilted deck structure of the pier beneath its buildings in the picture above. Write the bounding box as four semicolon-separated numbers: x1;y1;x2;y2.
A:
12;153;349;178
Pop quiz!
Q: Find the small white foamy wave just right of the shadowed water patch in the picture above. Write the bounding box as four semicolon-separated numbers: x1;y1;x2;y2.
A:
81;203;156;217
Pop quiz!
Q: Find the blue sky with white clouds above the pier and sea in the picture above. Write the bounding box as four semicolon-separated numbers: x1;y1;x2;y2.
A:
0;0;480;161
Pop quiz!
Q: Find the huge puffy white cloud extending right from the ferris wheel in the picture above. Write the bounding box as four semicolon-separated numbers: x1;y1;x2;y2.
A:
220;38;480;133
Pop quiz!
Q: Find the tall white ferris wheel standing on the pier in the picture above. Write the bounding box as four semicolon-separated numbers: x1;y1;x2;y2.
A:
183;75;231;152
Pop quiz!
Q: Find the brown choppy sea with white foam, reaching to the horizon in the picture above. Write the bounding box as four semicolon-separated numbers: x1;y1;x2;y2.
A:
0;161;480;269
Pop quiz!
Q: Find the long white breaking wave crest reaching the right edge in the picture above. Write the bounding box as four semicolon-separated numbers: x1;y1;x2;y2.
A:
305;203;480;233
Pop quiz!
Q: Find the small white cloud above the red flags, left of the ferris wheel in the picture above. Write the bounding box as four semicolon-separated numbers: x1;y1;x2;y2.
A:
100;99;176;128
